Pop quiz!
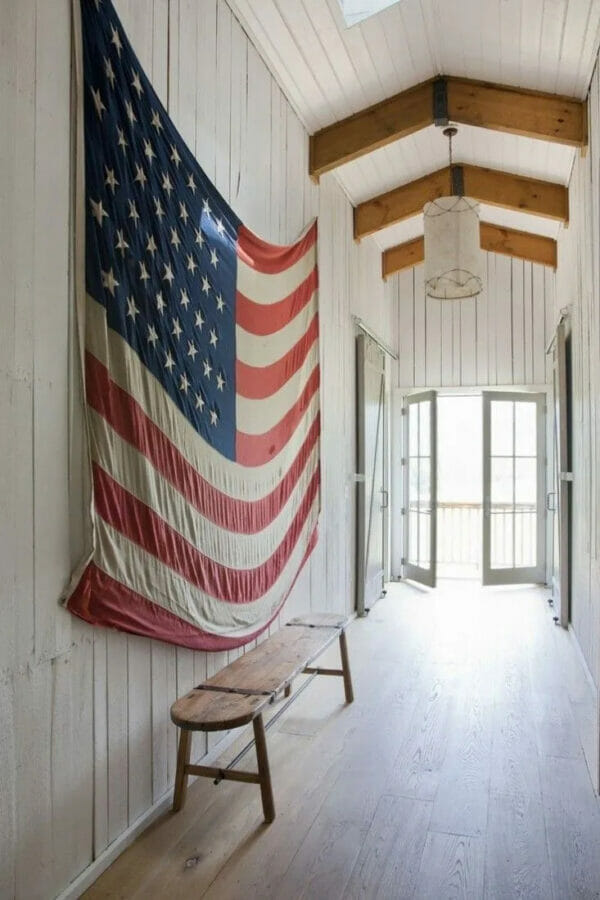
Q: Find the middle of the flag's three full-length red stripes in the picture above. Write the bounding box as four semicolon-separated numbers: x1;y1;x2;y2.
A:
92;462;319;603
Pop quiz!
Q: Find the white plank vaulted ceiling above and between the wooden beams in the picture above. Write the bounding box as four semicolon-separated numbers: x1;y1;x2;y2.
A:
229;0;600;247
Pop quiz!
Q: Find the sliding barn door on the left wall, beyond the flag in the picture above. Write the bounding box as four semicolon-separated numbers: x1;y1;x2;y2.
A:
356;334;388;616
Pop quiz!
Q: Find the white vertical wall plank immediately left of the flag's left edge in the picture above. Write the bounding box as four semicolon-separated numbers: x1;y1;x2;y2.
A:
30;0;71;659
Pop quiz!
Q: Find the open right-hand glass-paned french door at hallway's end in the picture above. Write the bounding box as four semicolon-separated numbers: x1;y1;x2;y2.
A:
483;391;546;585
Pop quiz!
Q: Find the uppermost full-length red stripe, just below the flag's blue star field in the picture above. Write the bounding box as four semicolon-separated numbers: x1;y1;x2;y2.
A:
86;351;320;534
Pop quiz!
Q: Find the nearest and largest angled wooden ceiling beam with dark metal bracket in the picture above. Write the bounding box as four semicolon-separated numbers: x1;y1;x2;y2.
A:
310;77;587;178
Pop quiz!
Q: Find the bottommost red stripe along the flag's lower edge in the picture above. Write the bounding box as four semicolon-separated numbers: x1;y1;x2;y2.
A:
67;528;318;650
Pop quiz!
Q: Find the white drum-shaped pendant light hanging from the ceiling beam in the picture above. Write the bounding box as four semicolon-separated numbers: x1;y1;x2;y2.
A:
423;128;483;300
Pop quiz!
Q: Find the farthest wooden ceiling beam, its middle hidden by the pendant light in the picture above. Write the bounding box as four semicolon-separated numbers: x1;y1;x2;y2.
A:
381;222;557;279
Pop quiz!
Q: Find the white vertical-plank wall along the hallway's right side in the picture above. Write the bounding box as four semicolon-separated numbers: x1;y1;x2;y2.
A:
556;56;600;692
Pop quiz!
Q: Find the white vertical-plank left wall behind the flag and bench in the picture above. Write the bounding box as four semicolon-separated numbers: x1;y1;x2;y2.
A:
0;0;397;900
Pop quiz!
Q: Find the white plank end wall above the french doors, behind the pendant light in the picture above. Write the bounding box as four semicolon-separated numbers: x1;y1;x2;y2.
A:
390;253;555;387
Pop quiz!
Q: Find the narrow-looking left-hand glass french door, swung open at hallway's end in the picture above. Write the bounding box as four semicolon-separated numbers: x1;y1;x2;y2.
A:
403;391;437;587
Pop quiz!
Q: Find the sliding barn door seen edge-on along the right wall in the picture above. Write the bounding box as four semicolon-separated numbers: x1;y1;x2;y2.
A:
552;322;572;628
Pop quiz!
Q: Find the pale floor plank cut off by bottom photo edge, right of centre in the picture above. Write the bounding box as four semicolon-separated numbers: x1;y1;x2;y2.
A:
413;831;486;900
